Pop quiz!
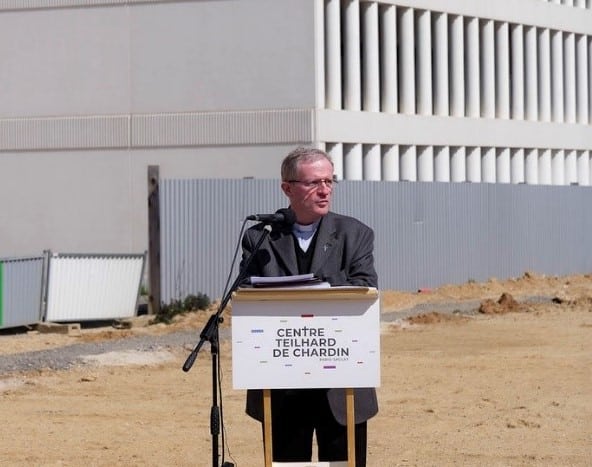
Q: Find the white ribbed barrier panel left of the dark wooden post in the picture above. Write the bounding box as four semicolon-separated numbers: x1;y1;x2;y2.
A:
45;254;145;321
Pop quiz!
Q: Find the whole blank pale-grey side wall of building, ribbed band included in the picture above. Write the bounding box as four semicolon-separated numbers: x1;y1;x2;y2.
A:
0;0;323;256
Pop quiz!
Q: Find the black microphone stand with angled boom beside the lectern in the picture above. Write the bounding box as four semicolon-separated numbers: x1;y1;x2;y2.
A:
183;224;271;467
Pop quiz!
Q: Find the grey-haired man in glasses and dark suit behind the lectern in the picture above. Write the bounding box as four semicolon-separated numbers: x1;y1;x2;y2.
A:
242;148;378;467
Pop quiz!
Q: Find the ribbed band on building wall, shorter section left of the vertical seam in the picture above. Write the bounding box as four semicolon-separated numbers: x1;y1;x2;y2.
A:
0;115;129;151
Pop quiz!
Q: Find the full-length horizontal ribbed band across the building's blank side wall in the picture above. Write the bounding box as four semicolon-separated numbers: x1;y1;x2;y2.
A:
0;109;314;151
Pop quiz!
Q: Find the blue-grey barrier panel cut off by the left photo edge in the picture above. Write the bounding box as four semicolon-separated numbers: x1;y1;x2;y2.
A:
0;257;44;328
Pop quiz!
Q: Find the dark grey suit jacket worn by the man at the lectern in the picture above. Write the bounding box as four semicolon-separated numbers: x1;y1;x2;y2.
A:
241;212;378;425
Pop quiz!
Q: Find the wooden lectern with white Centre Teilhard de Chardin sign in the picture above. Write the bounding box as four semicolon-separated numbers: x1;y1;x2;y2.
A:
232;287;380;467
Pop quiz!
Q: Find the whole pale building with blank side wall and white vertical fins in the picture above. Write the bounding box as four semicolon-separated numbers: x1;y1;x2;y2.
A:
0;0;592;257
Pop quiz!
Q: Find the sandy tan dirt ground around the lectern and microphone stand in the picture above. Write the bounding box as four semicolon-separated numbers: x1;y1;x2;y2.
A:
0;274;592;467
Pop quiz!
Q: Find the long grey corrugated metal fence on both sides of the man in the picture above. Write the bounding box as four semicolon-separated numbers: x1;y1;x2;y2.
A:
160;180;592;303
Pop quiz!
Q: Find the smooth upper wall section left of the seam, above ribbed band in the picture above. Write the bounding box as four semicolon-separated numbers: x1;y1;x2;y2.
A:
0;7;132;118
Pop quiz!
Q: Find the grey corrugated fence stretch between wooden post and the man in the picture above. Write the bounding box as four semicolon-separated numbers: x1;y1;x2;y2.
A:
160;179;286;303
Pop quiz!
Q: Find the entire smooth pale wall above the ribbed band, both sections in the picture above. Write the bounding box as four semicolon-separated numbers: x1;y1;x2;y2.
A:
0;0;315;118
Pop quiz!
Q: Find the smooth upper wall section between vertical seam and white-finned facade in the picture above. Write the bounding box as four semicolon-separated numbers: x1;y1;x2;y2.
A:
129;0;315;113
